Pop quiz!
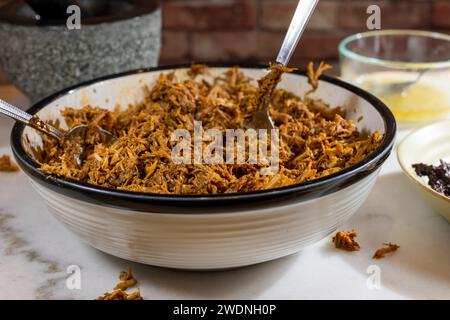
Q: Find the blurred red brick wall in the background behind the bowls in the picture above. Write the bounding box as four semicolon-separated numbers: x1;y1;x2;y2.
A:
161;0;450;66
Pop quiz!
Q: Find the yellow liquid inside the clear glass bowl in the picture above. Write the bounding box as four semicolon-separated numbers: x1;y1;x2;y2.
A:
356;72;450;123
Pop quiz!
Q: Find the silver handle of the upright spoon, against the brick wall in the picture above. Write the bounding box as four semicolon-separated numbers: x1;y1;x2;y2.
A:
277;0;319;66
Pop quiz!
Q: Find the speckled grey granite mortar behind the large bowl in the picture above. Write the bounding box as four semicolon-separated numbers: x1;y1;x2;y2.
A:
0;0;162;102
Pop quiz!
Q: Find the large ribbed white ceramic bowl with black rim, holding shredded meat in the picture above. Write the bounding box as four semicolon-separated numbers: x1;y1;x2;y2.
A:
12;66;396;270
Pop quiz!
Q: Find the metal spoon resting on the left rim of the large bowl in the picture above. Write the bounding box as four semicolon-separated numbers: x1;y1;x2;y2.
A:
0;99;116;149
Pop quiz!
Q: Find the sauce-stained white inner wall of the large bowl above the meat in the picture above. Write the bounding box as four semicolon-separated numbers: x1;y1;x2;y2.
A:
22;67;386;157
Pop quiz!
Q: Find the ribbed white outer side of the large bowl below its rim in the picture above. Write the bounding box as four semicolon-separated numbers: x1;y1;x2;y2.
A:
32;170;379;270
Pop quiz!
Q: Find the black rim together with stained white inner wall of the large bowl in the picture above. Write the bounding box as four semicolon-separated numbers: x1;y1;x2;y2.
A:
11;64;396;210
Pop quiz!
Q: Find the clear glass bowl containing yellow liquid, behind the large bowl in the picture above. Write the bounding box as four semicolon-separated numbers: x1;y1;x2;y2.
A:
339;30;450;126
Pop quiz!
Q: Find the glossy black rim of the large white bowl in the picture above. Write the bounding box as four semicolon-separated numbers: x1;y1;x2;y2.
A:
11;63;397;212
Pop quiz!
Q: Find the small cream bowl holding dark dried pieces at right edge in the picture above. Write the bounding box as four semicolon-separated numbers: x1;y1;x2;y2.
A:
397;121;450;222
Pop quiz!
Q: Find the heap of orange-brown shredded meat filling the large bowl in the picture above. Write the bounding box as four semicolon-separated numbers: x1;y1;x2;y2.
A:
34;66;383;194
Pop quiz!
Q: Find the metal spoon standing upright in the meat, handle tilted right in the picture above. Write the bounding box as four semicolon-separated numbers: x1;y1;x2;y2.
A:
251;0;319;129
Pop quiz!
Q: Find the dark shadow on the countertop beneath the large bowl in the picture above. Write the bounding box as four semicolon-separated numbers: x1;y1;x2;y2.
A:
92;249;301;300
